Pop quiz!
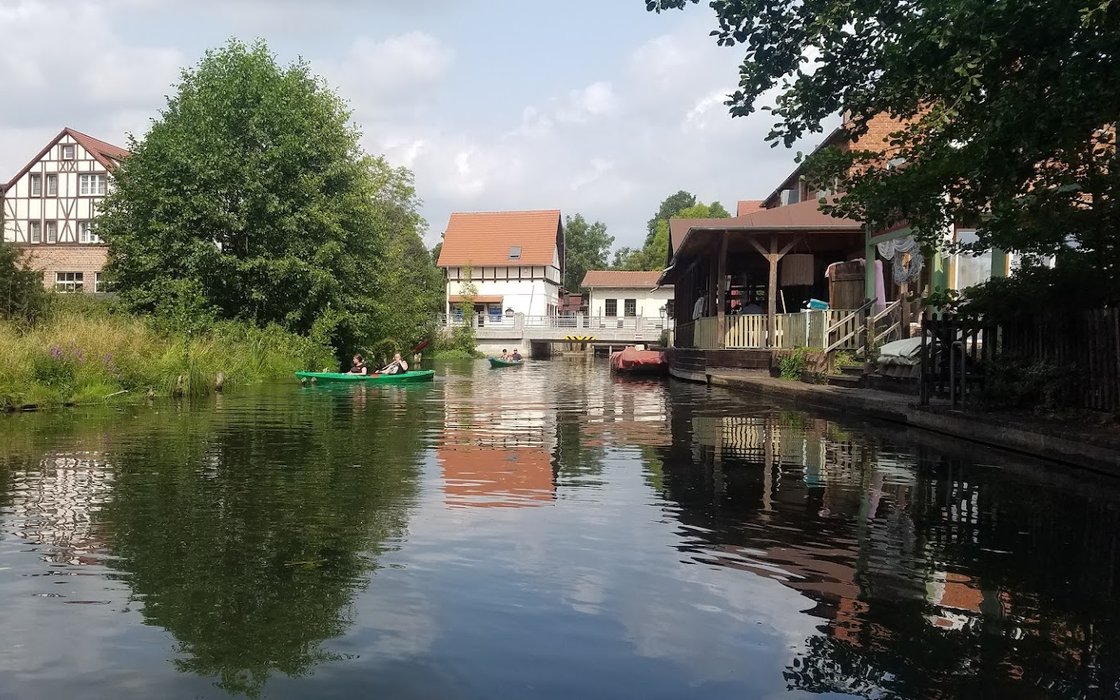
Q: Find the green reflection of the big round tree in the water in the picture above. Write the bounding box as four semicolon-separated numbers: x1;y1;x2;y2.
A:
104;394;422;696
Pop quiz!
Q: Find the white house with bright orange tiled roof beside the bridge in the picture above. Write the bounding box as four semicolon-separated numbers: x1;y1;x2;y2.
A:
436;209;564;323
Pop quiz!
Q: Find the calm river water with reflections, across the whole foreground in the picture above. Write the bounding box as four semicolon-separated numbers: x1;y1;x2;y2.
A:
0;360;1120;700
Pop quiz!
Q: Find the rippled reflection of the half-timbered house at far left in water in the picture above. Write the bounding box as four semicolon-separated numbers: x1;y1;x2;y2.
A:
7;452;113;564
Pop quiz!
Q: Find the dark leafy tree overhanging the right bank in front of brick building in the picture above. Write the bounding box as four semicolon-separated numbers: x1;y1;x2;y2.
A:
646;0;1120;286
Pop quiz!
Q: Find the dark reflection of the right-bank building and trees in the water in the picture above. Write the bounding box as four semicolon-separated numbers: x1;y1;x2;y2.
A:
661;409;1120;700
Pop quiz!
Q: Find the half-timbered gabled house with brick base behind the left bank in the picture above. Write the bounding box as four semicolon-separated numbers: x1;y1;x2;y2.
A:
0;128;129;292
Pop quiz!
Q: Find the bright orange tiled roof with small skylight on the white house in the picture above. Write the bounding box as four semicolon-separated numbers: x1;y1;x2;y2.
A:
437;209;560;268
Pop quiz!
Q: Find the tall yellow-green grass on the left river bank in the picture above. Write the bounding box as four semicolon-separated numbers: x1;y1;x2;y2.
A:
0;300;336;409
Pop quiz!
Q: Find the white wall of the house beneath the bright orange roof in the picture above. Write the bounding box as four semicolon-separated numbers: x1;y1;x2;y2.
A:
446;264;560;316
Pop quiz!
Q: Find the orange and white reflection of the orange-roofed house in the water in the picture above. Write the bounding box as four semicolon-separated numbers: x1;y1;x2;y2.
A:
436;383;556;507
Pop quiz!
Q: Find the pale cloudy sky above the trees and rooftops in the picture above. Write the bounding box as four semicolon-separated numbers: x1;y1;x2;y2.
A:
0;0;824;250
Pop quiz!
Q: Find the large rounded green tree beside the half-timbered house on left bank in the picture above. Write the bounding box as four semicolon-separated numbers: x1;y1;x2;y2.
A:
99;41;438;352
